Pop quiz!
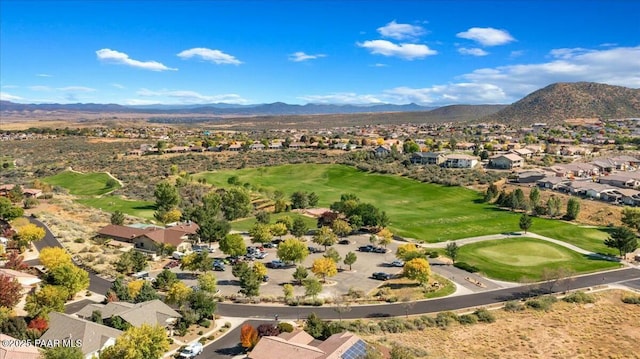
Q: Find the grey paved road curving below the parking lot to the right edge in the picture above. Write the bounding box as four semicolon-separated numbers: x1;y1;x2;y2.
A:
218;268;640;319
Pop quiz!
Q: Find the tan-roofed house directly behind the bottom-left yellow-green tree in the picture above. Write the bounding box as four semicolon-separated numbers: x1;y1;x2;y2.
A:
76;299;182;329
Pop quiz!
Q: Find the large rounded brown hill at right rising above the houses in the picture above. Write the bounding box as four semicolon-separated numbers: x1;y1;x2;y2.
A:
482;82;640;125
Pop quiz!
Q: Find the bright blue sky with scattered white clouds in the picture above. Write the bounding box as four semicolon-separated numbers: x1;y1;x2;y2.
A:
0;0;640;106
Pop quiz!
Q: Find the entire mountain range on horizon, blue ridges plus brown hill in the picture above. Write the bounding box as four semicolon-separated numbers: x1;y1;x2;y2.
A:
0;82;640;125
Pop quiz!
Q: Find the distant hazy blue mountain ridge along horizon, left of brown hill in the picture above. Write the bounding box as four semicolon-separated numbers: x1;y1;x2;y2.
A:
0;101;434;116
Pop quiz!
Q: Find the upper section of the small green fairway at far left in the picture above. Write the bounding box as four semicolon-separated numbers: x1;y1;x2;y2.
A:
42;171;121;196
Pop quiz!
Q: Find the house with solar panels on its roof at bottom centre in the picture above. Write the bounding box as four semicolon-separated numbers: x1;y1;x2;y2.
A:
248;329;368;359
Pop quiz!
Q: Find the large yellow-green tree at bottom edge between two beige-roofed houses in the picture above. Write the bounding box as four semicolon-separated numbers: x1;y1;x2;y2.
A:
100;324;169;359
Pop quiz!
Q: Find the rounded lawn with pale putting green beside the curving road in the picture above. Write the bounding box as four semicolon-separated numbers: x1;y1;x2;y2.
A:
457;237;620;282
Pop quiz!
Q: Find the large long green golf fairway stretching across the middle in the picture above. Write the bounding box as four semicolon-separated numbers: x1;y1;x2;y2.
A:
194;164;610;253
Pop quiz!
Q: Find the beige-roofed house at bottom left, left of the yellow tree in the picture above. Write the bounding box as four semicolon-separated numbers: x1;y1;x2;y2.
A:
40;312;122;359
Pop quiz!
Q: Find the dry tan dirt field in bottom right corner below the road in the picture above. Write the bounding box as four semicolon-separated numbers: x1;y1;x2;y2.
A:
365;290;640;358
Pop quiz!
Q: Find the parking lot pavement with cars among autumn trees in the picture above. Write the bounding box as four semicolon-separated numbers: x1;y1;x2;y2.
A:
151;235;402;298
